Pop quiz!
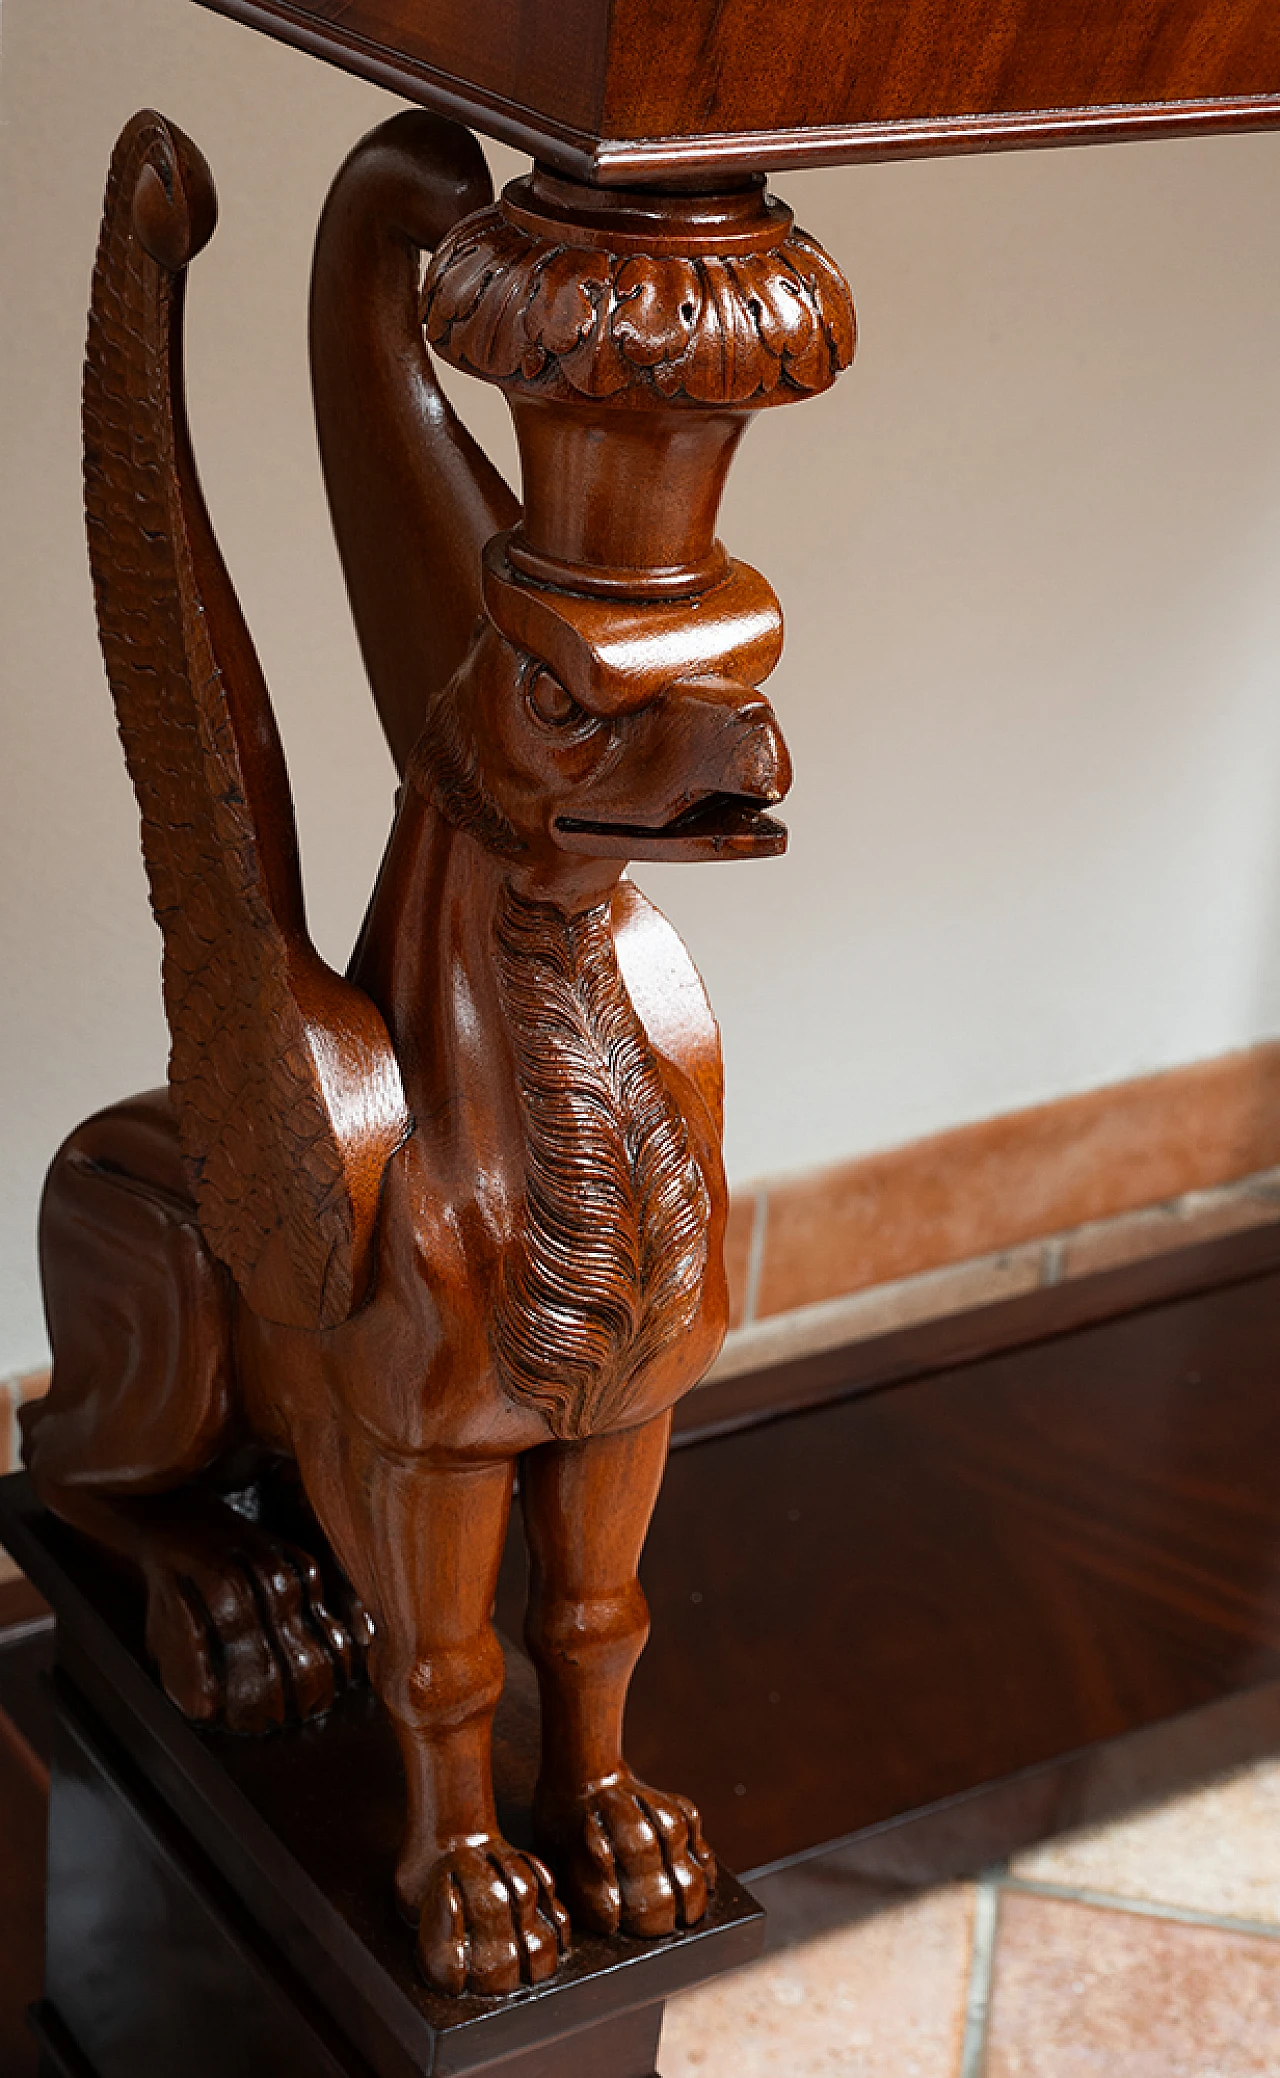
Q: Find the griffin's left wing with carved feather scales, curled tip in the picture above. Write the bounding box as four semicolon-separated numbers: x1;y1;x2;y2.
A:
83;110;411;1328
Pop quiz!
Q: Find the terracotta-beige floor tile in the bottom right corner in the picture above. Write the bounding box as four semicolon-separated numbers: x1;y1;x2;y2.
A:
989;1891;1280;2078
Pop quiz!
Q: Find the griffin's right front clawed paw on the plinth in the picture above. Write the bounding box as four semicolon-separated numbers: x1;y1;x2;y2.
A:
534;1773;715;1937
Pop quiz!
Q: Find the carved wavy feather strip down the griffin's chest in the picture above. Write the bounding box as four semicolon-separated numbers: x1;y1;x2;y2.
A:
490;885;711;1440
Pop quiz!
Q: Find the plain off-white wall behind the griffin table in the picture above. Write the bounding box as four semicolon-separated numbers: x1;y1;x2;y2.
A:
0;0;1280;1376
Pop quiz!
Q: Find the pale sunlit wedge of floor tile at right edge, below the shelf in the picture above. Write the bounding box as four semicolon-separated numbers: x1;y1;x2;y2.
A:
1012;1760;1280;1920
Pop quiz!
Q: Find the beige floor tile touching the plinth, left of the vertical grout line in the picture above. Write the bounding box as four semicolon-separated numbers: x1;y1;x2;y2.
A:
659;1885;972;2078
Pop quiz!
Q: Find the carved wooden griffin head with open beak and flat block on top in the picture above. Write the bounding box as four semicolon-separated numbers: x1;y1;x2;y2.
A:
407;536;792;894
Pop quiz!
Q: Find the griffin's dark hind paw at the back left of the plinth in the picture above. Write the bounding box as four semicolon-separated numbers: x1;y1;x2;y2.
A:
145;1525;355;1733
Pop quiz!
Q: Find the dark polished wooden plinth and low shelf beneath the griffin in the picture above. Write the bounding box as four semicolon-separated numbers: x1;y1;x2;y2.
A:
0;1228;1280;2078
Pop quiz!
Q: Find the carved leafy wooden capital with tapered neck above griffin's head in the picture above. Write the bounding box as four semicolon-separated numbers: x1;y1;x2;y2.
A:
424;168;854;598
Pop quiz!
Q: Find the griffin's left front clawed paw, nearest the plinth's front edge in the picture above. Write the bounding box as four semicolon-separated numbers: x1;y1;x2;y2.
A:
418;1839;571;1999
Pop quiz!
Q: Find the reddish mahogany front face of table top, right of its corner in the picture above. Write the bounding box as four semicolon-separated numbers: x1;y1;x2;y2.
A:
603;0;1280;156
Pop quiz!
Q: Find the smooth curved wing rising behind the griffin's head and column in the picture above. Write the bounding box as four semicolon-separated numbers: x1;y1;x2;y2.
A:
312;108;519;773
